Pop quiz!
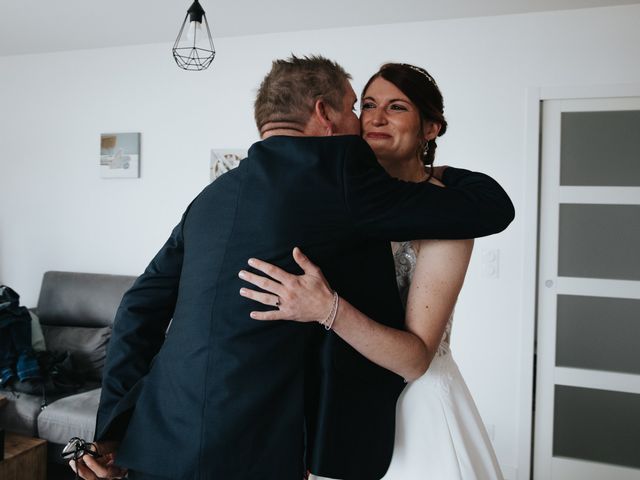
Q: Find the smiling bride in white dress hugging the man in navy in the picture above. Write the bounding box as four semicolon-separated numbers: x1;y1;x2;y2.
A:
242;64;503;480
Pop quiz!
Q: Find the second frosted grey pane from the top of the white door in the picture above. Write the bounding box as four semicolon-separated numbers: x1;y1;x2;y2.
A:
558;203;640;280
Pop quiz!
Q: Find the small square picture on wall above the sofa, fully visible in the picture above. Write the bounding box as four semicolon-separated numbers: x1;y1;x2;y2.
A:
100;132;140;178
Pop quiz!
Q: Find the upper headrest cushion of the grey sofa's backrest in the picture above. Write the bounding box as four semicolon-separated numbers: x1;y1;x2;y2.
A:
36;271;135;327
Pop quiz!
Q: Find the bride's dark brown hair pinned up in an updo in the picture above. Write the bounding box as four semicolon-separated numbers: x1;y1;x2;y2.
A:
361;63;447;166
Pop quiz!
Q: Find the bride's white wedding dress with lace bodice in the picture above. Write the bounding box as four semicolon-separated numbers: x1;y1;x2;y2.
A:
310;242;503;480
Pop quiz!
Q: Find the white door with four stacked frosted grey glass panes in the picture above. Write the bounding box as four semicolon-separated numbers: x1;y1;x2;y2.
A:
536;94;640;480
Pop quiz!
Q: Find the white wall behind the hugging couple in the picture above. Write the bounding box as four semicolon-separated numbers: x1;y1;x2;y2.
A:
0;6;640;479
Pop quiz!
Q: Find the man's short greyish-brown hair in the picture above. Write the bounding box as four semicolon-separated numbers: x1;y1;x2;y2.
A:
254;55;351;132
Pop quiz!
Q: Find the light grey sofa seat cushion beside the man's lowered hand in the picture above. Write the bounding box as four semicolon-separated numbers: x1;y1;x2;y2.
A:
38;388;101;444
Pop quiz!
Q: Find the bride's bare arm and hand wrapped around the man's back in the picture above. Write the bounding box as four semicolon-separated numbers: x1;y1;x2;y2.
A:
240;240;472;381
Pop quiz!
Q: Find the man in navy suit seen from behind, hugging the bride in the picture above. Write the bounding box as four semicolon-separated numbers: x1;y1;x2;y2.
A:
78;57;513;480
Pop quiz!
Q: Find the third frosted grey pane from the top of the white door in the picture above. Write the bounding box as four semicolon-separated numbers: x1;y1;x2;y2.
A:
556;295;640;376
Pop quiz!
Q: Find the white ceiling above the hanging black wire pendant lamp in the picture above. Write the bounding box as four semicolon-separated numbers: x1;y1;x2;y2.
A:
0;0;640;56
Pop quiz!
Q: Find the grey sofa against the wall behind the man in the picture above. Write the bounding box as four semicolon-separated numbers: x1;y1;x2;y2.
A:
0;271;135;452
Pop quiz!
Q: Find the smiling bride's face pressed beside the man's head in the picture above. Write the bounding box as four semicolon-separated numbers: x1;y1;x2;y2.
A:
360;77;424;161
